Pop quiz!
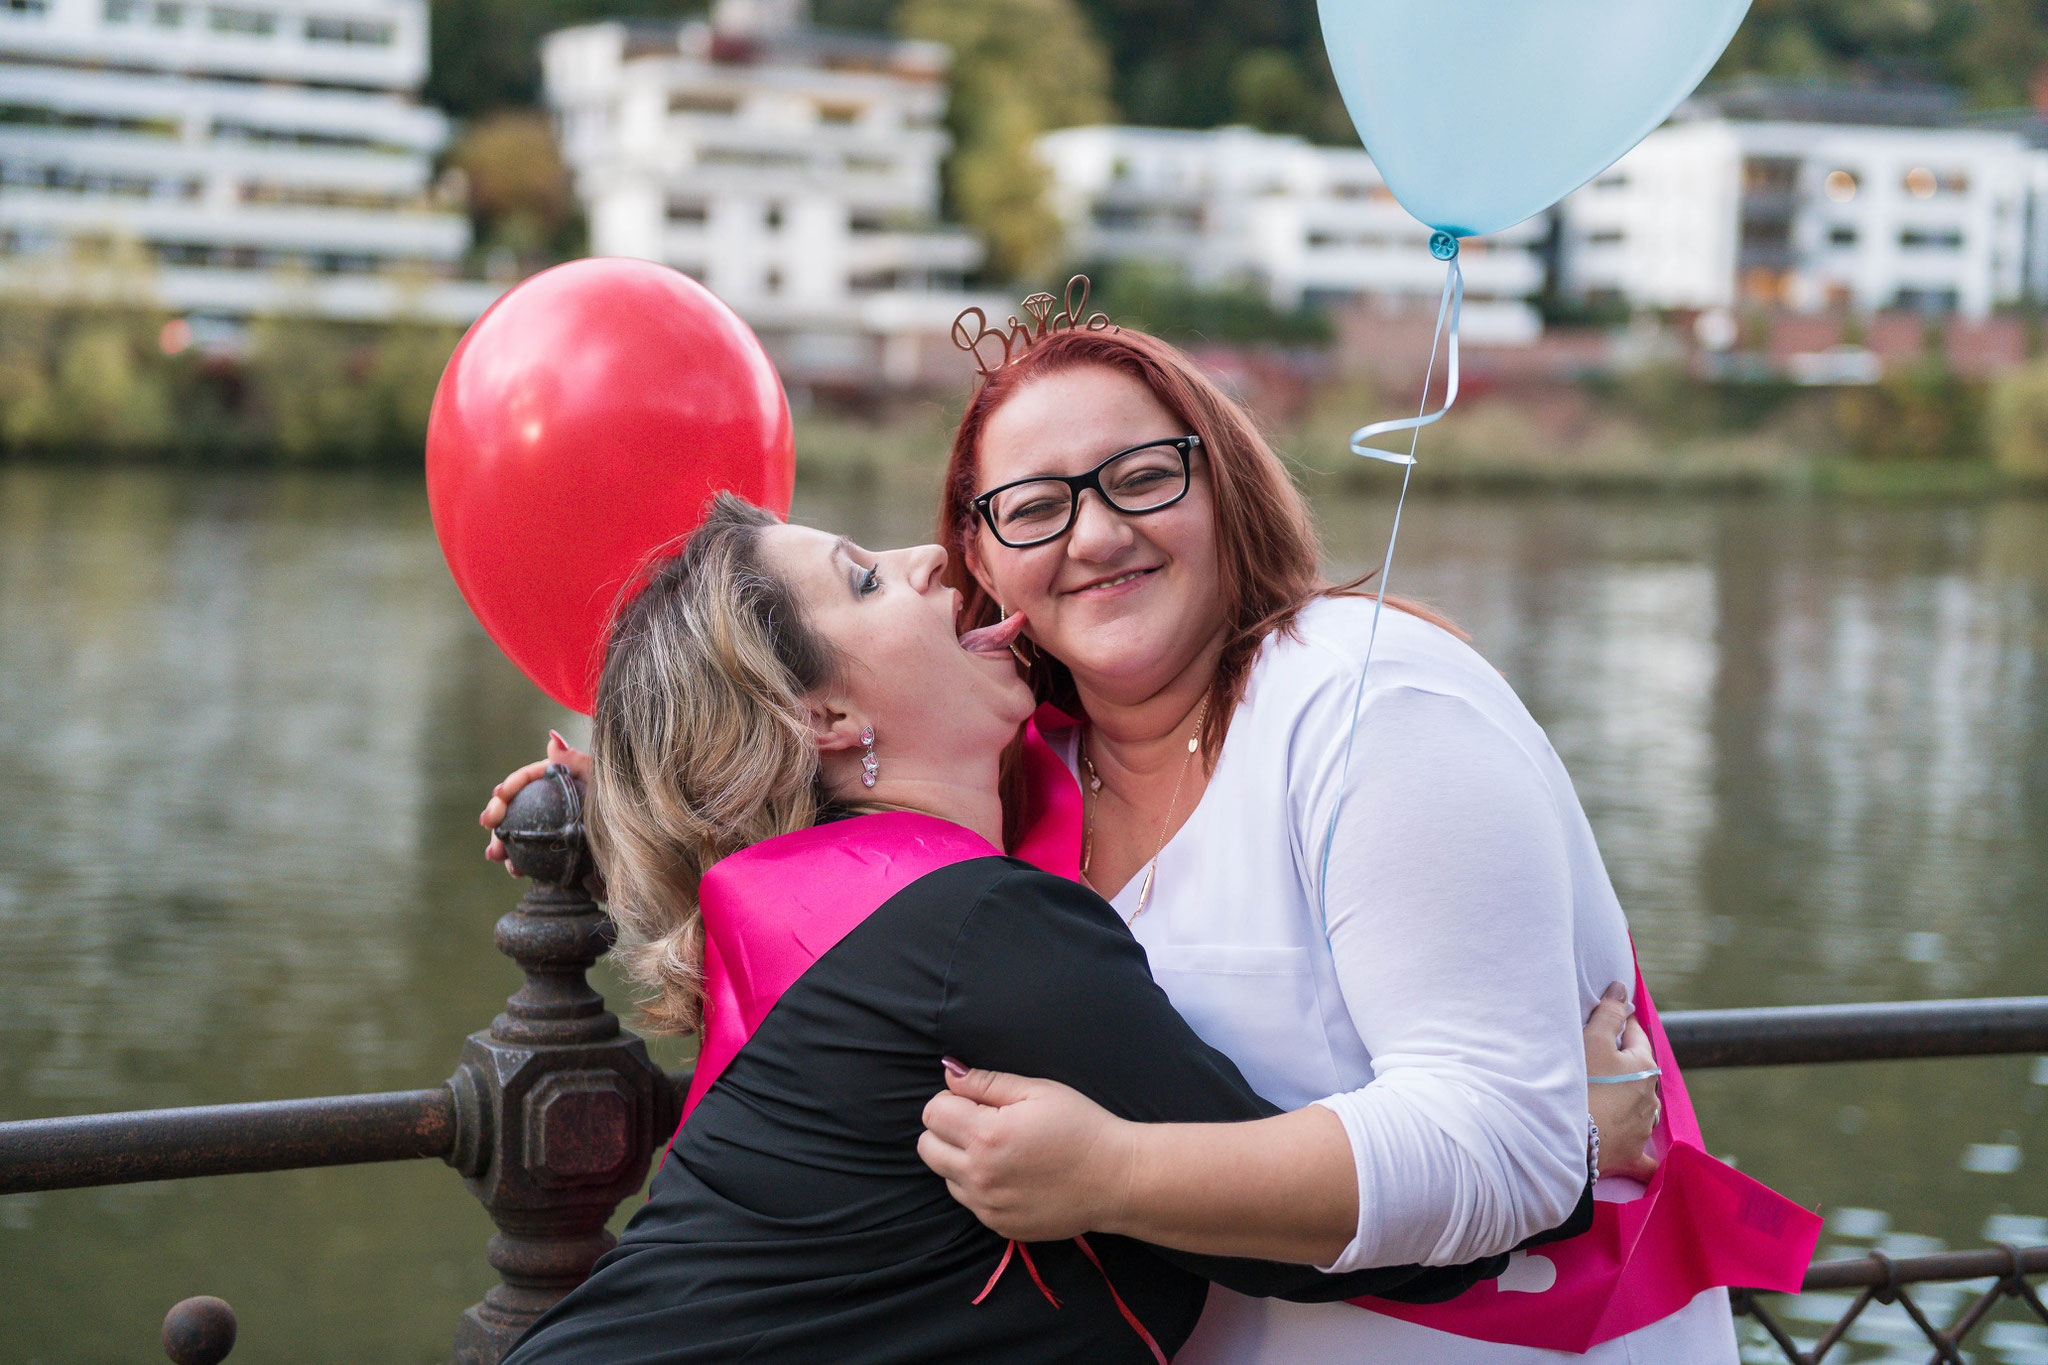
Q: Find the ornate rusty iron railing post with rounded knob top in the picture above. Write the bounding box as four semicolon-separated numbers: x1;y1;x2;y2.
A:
446;767;676;1365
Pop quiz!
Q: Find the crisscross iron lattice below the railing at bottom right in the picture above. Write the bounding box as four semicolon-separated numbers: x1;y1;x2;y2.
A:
1731;1242;2048;1365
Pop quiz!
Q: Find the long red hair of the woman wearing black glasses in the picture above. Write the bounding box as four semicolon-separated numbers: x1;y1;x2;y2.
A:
938;327;1462;789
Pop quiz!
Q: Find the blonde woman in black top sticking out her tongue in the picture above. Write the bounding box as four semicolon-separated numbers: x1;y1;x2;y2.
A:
487;497;1597;1365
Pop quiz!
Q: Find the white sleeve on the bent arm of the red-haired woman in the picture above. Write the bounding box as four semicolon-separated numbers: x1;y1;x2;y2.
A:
1290;688;1620;1269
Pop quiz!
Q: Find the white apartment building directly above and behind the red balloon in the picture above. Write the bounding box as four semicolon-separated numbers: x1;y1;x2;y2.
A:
541;0;991;387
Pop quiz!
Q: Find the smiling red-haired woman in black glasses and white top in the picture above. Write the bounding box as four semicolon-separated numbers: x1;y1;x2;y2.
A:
485;315;1784;1365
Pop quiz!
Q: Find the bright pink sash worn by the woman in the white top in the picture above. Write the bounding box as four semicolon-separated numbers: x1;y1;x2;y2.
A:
1018;706;1821;1351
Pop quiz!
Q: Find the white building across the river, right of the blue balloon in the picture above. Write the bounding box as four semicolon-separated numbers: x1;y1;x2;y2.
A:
1559;92;2048;319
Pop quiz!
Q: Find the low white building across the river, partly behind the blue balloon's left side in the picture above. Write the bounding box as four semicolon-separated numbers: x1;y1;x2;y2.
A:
1038;127;1548;344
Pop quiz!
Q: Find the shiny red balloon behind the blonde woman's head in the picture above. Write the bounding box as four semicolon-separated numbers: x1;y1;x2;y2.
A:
426;260;797;712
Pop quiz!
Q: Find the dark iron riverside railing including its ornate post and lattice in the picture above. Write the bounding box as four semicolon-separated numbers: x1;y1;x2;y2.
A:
0;776;2048;1365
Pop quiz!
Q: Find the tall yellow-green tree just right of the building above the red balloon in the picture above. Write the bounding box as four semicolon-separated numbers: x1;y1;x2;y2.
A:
897;0;1114;280
